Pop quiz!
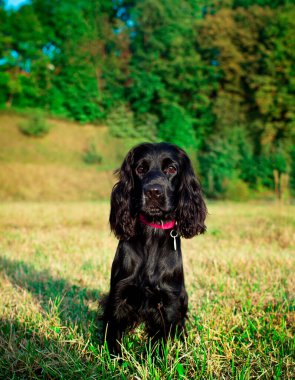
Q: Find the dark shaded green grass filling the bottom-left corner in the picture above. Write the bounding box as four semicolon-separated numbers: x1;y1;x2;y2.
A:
0;319;120;380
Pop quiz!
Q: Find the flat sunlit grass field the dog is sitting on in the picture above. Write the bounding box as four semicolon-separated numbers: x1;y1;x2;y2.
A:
0;202;295;379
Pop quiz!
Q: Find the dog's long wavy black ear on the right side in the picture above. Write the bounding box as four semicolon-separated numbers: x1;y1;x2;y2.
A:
176;152;207;238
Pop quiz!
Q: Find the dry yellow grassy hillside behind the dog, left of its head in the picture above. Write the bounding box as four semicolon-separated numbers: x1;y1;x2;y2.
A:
0;113;140;201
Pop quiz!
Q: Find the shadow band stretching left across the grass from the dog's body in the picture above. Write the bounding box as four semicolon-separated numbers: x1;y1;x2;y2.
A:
0;257;101;339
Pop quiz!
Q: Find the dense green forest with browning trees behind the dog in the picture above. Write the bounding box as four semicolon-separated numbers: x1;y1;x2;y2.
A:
0;0;295;199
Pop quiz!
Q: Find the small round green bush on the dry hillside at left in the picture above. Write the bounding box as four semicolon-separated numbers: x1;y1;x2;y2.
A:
19;110;50;137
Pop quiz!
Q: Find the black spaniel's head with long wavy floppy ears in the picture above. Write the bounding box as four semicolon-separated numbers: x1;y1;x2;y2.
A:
110;143;207;239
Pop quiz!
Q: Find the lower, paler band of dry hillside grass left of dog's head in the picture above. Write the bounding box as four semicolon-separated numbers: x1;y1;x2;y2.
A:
0;163;114;201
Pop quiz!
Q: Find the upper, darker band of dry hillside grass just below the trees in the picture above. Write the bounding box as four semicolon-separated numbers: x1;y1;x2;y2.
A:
0;113;120;167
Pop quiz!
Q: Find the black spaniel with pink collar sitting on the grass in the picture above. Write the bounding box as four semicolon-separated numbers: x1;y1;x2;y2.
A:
104;143;207;353
